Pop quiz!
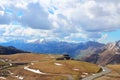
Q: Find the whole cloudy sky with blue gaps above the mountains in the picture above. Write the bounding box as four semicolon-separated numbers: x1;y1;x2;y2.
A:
0;0;120;43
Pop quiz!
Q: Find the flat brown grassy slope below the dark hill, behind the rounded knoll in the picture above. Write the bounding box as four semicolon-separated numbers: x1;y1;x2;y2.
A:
0;53;61;62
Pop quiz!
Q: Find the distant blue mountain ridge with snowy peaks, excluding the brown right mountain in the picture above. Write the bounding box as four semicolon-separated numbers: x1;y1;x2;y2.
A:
0;39;104;57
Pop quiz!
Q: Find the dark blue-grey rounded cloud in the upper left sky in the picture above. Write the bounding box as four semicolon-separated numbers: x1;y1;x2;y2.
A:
21;3;52;29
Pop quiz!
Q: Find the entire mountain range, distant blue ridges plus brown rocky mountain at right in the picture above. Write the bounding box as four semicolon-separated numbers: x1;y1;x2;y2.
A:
0;40;120;65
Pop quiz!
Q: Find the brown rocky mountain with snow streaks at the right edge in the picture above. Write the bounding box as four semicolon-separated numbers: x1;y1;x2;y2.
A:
83;41;120;65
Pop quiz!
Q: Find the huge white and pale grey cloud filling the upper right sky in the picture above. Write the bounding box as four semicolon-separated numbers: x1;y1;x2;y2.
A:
46;0;120;39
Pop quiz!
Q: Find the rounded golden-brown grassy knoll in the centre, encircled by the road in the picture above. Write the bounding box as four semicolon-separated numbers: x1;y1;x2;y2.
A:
31;60;99;74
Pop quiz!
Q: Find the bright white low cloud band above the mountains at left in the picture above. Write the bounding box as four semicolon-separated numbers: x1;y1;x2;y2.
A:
0;25;54;41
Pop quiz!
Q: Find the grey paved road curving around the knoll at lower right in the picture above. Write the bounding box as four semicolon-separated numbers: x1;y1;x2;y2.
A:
80;66;111;80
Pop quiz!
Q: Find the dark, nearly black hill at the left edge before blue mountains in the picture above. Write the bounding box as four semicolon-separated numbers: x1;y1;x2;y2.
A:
0;46;28;55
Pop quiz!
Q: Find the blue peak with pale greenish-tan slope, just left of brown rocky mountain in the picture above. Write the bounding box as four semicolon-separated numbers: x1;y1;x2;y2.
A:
76;41;104;59
